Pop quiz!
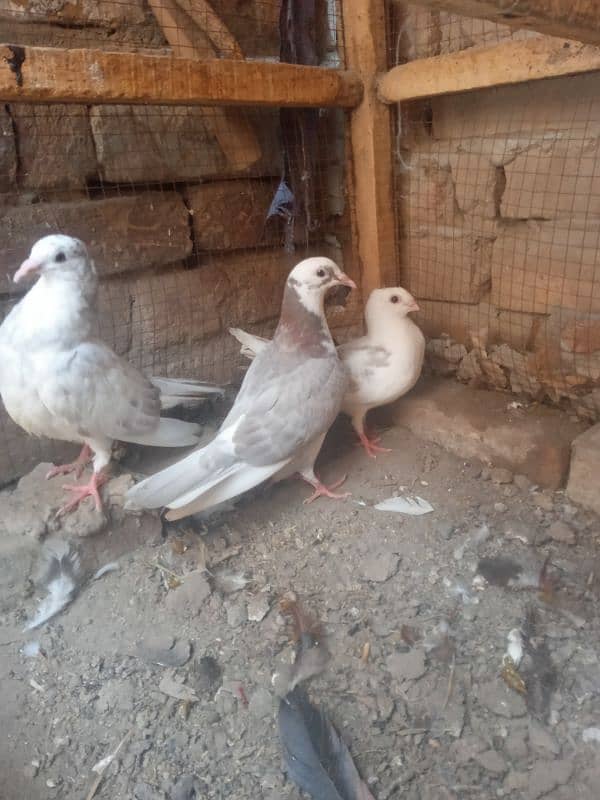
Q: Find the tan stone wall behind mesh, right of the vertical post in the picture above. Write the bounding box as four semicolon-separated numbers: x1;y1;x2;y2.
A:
397;6;600;420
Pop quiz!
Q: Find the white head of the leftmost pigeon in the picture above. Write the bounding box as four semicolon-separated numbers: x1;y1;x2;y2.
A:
13;233;93;283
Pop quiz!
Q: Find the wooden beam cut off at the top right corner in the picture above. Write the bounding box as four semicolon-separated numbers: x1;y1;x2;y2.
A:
418;0;600;45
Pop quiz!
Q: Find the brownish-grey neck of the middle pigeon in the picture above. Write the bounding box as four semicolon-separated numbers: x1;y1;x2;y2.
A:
273;283;335;357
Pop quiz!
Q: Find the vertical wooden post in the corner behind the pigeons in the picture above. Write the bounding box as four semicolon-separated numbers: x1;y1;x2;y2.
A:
342;0;399;300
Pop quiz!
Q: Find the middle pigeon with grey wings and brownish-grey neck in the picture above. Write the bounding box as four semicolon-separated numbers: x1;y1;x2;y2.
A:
123;257;356;519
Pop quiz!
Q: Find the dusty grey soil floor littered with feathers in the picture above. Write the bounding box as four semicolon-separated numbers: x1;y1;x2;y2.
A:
0;418;600;800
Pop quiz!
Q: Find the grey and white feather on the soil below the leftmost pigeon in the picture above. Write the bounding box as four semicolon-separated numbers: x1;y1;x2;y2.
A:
24;539;81;631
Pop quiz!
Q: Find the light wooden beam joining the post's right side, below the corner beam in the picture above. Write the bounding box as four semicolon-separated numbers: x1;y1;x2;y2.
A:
378;39;600;103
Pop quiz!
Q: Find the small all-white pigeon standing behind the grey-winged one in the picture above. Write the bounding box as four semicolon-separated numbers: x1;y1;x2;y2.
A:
229;286;425;457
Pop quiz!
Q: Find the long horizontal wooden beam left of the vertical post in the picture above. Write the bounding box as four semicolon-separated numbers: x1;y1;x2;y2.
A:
0;44;362;108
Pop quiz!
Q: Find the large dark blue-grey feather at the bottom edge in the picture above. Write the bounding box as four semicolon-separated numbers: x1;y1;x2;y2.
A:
278;687;374;800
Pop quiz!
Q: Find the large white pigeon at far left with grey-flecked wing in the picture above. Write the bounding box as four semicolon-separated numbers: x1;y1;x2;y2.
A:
0;234;221;513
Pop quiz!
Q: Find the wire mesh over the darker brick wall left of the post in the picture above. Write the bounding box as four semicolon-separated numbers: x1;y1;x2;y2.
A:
0;0;358;483
